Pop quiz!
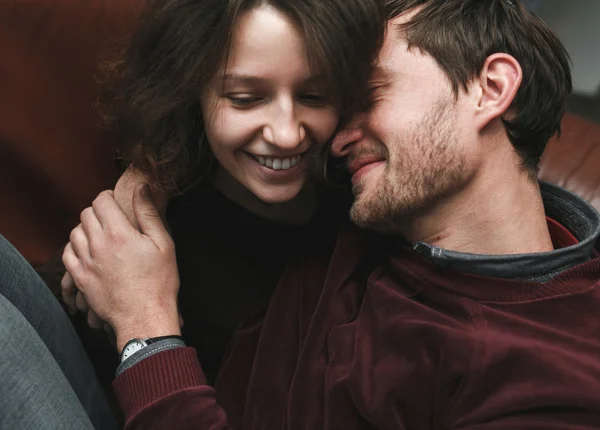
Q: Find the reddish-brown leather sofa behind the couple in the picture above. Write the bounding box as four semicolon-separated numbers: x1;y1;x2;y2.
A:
0;0;600;266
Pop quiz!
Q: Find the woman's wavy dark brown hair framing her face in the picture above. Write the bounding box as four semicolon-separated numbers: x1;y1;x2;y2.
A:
100;0;385;193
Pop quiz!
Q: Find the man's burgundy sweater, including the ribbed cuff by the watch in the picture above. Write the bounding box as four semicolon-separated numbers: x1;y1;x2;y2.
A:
113;222;600;430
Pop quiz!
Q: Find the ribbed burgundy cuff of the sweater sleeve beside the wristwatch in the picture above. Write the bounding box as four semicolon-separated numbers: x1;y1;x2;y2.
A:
112;347;206;417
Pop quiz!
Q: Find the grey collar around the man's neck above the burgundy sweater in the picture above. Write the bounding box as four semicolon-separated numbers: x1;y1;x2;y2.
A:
413;182;600;282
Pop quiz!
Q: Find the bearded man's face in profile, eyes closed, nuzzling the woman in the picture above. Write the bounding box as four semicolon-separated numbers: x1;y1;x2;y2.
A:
332;16;478;232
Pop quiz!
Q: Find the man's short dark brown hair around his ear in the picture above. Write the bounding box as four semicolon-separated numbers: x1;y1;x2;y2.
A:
386;0;573;175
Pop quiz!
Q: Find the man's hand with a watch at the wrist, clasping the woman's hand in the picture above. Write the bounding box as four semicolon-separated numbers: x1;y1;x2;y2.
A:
63;184;180;349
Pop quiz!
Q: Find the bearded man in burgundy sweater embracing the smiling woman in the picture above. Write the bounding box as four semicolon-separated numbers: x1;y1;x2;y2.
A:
65;0;600;430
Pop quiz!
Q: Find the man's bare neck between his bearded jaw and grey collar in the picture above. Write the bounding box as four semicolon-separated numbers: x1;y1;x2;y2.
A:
403;151;554;255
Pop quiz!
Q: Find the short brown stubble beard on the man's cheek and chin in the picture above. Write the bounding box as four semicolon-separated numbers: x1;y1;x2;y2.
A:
350;101;468;233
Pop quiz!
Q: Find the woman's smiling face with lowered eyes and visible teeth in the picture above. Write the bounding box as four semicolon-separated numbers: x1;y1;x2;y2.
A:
201;6;339;203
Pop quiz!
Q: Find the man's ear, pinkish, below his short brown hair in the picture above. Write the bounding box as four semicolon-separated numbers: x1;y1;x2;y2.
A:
473;53;523;130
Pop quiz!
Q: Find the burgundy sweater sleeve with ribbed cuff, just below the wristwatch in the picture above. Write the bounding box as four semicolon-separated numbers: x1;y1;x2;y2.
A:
113;348;229;430
